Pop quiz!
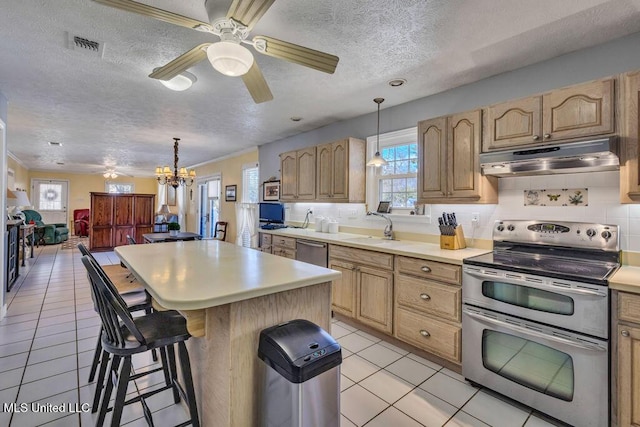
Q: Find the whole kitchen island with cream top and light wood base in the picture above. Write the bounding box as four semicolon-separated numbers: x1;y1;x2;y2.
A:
115;240;340;427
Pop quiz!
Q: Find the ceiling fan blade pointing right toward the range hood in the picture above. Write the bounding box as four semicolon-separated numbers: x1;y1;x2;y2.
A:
253;36;340;74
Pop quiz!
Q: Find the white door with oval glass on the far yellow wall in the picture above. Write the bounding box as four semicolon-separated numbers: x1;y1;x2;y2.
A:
31;179;69;224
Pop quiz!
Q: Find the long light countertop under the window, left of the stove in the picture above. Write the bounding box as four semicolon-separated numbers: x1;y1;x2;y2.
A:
259;228;491;265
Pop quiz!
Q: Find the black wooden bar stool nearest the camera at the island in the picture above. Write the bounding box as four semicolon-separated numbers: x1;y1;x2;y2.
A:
82;255;200;426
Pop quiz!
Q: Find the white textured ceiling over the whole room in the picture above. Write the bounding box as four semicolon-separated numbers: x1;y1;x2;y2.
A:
0;0;640;176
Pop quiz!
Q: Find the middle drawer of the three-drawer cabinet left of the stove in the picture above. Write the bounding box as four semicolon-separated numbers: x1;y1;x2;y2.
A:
395;274;462;322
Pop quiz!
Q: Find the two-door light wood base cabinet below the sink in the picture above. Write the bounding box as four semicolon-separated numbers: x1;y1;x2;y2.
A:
329;245;393;334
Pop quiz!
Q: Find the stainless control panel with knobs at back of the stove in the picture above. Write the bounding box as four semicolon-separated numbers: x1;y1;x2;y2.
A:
493;220;620;251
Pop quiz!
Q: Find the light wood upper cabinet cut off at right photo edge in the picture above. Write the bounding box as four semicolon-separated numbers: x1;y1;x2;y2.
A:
620;71;640;203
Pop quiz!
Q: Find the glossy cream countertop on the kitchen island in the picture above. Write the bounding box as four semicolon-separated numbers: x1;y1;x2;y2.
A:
115;240;340;310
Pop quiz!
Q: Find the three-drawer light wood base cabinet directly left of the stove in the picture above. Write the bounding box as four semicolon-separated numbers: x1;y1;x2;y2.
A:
393;256;462;364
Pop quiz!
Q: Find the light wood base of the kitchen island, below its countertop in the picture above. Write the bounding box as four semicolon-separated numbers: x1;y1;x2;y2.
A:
179;282;331;427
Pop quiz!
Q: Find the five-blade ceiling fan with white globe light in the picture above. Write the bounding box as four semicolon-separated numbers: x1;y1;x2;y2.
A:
94;0;339;104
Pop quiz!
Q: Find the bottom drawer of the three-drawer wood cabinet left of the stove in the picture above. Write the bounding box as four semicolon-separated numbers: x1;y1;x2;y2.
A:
395;308;462;363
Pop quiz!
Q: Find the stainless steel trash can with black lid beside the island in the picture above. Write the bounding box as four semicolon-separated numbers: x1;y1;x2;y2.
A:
258;319;342;427
